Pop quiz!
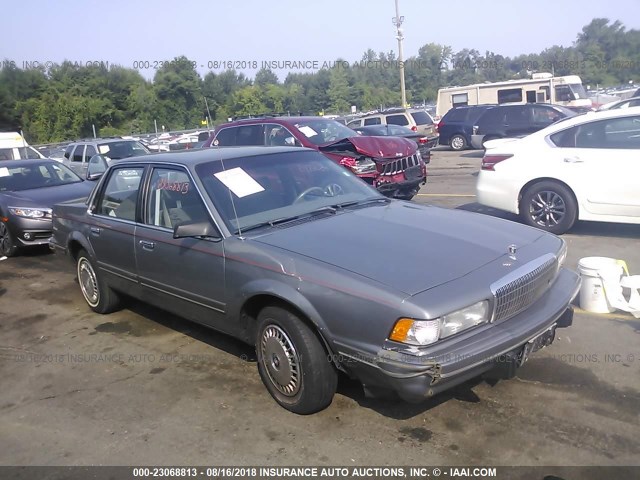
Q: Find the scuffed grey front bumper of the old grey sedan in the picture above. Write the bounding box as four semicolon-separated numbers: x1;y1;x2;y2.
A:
339;269;580;402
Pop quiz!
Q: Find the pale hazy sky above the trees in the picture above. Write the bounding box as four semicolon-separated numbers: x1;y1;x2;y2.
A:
0;0;640;79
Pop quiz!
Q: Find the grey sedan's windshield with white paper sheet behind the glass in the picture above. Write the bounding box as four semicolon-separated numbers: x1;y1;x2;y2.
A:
196;149;385;233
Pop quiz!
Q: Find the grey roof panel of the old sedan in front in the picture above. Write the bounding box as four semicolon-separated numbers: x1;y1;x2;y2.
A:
117;146;317;166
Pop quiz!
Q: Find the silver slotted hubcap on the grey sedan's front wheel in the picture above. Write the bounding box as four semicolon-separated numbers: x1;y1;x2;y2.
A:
260;325;301;397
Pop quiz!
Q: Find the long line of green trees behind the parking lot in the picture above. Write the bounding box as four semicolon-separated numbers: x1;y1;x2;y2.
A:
0;18;640;143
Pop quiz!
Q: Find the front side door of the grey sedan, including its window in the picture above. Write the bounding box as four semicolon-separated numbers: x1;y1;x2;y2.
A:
135;166;229;330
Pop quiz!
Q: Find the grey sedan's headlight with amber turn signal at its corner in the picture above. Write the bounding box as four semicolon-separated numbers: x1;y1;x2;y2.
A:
389;300;489;346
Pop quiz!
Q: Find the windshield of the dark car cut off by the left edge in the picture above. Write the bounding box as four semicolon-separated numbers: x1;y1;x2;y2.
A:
0;161;82;192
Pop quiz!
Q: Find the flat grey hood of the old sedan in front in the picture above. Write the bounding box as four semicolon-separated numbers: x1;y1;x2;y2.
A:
253;201;545;295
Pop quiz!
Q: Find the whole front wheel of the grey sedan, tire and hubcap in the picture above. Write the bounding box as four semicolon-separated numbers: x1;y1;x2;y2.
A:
256;306;338;415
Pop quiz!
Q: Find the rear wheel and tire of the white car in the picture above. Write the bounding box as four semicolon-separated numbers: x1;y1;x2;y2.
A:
520;181;578;235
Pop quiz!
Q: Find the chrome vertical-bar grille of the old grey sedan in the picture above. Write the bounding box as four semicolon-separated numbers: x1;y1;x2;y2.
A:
491;254;558;321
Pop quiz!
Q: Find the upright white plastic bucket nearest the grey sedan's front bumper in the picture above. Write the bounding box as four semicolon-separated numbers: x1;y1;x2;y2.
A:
578;257;623;313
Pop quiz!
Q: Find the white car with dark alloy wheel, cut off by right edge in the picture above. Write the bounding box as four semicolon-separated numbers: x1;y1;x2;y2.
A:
477;107;640;234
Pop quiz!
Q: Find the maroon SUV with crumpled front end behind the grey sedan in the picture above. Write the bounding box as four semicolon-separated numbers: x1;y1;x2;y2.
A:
204;117;427;200
